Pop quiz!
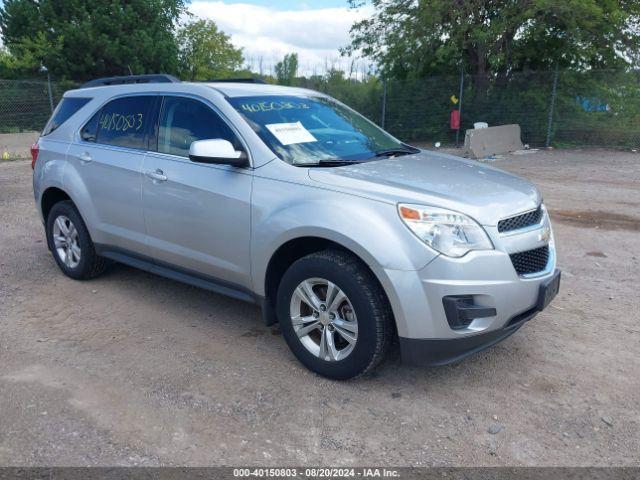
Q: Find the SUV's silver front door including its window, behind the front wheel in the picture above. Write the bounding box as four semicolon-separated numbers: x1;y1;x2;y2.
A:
143;96;253;288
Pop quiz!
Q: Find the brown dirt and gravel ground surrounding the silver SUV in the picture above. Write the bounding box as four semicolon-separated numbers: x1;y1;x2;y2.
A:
0;151;640;466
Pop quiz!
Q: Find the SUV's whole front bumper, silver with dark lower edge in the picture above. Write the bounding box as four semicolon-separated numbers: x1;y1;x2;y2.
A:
376;232;559;365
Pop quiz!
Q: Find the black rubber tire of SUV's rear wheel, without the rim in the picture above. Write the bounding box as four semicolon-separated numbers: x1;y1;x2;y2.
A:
47;200;107;280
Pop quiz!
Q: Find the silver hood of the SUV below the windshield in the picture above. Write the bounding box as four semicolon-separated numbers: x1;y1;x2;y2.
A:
309;151;541;226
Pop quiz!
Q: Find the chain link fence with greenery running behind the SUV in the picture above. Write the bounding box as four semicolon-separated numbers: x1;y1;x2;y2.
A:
0;70;640;149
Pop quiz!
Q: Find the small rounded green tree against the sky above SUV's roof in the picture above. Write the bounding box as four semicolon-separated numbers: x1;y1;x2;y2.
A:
177;20;243;80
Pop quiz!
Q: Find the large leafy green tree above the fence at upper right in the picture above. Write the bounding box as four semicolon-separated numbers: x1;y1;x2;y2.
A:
344;0;640;78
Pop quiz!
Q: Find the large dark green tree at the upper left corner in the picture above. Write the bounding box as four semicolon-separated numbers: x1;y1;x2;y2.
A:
0;0;185;80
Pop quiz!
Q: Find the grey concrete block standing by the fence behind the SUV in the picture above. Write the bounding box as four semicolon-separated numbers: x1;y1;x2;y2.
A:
464;123;524;158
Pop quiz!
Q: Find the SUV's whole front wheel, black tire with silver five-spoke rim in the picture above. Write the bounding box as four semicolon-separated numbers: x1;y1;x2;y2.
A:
277;250;393;380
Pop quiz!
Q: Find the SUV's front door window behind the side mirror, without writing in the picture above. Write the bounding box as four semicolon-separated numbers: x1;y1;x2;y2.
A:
158;97;240;157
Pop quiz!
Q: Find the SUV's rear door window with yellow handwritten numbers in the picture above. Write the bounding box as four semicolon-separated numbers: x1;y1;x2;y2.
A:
89;96;156;149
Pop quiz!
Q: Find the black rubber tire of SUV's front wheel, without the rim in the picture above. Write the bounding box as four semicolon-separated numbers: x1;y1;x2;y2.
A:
277;250;394;380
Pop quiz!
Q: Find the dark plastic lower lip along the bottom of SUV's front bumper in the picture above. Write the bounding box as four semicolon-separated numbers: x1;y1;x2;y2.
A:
400;270;560;366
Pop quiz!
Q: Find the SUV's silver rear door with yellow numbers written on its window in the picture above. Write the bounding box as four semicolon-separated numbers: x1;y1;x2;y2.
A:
68;95;159;255
